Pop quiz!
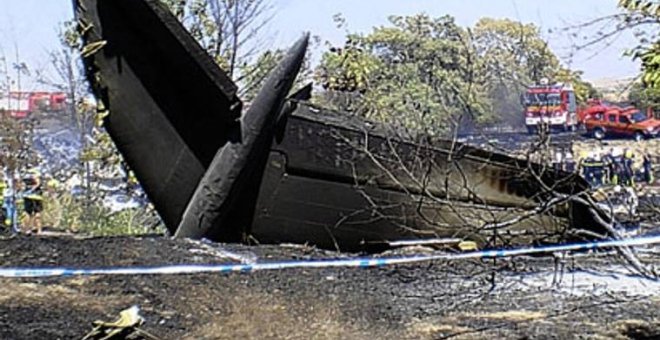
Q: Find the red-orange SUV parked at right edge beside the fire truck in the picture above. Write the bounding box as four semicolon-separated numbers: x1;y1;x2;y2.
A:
584;106;660;141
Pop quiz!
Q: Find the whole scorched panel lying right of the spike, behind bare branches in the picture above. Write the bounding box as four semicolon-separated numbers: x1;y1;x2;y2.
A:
250;104;588;250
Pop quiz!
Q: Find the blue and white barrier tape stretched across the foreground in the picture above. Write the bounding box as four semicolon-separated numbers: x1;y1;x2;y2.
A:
0;236;660;278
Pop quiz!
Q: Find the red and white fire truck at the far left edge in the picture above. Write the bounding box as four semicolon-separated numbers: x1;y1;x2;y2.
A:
0;92;67;118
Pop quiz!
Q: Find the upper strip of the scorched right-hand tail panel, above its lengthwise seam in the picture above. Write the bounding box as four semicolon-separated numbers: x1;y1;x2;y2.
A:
273;105;586;208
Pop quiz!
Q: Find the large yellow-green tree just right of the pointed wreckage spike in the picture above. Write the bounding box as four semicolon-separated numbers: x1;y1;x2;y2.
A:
316;15;490;134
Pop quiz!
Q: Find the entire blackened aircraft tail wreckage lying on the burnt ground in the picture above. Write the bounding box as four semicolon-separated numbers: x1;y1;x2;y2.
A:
74;0;597;250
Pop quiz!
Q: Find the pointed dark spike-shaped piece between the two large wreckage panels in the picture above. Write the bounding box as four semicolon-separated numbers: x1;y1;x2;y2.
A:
174;35;309;238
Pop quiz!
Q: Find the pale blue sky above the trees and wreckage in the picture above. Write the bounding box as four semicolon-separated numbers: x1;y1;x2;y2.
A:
0;0;639;90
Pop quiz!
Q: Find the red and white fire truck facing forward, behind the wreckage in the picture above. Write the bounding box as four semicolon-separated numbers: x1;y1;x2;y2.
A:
522;83;579;133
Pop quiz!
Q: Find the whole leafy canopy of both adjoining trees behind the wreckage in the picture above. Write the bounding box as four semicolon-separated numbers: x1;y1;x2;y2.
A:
316;14;594;133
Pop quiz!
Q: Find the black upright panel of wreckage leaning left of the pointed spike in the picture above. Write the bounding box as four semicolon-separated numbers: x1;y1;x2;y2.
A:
74;0;241;232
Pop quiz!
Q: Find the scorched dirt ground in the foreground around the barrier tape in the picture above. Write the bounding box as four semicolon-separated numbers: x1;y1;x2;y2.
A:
0;236;660;339
